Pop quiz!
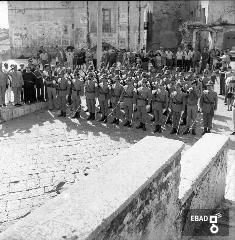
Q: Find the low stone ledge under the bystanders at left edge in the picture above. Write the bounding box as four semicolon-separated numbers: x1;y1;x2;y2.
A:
0;102;48;121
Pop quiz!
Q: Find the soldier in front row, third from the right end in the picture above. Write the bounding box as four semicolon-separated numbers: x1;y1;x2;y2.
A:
170;83;186;134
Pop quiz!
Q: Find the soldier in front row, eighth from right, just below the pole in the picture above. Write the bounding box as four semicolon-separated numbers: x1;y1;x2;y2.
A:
98;77;109;123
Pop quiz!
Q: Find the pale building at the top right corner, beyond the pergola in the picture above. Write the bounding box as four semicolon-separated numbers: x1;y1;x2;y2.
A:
207;0;235;49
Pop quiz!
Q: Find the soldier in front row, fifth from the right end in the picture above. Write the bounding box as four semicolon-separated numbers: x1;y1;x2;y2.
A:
134;78;151;131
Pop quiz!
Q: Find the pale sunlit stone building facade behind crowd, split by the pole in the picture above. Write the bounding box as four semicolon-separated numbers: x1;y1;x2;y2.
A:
8;1;147;57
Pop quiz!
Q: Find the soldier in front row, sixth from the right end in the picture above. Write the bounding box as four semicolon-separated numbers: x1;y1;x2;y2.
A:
120;77;134;127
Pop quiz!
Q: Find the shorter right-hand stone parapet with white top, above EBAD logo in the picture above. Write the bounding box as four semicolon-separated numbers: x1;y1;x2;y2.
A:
179;133;229;239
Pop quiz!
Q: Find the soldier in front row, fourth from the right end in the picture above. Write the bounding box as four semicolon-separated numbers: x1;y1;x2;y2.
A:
152;82;168;133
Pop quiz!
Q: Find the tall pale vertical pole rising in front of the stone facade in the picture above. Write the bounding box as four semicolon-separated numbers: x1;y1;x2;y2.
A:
97;1;103;69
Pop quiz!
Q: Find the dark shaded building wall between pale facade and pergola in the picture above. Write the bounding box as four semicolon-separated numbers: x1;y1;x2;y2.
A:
148;1;205;49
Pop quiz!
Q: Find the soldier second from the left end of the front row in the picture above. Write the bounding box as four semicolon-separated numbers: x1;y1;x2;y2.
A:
57;68;71;117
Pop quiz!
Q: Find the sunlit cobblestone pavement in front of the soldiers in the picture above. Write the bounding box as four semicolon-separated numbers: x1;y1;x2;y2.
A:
0;74;235;232
